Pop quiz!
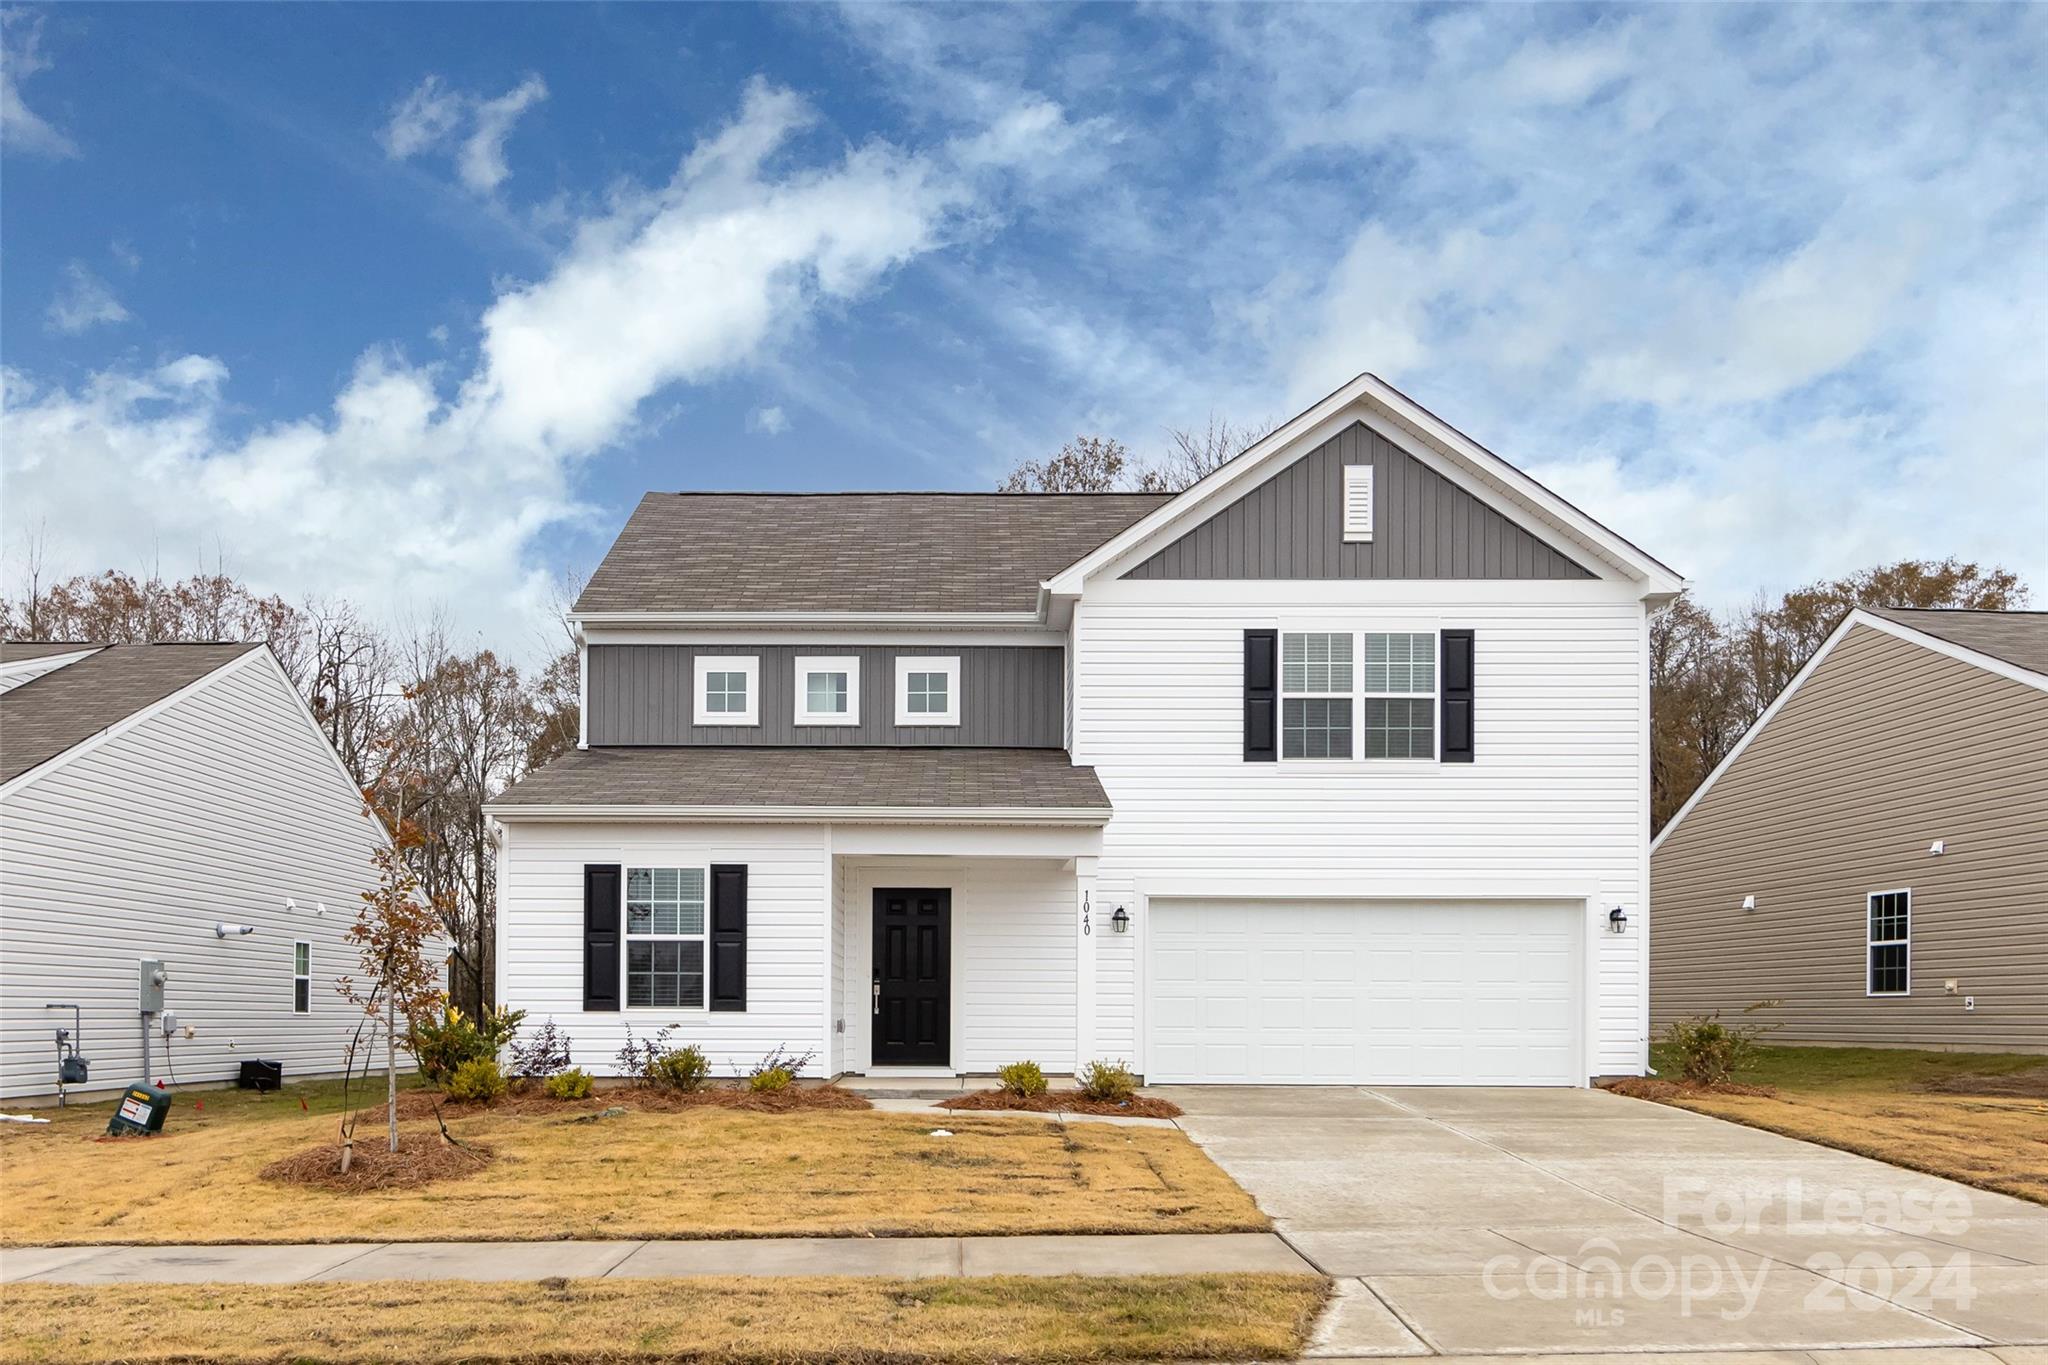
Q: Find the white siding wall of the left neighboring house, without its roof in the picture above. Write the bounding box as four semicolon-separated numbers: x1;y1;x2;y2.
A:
0;655;379;1095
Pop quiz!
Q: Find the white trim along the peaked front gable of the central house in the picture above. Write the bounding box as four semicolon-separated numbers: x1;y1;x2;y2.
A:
1047;375;1686;596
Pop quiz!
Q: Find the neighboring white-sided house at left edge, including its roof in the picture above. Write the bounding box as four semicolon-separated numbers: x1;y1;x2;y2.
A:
0;643;383;1097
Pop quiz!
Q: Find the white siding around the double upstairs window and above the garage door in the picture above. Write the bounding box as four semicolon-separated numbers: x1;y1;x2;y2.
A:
1073;579;1649;1074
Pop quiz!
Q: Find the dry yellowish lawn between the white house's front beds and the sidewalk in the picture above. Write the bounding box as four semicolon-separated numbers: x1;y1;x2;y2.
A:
0;1093;1270;1246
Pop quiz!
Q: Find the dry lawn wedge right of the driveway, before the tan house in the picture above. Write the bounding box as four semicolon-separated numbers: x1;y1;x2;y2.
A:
1667;1091;2048;1203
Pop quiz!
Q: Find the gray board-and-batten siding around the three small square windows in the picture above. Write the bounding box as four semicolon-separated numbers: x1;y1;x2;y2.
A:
590;641;1065;749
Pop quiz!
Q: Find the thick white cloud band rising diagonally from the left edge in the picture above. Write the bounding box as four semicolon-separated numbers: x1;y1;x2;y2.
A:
0;84;961;654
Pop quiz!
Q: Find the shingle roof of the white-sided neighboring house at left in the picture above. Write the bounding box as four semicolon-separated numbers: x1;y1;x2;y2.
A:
0;645;262;782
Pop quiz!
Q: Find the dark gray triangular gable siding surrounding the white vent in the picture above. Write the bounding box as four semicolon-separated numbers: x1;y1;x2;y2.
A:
1124;422;1595;579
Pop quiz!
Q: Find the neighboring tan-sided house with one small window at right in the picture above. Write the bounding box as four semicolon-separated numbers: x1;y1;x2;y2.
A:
1651;608;2048;1052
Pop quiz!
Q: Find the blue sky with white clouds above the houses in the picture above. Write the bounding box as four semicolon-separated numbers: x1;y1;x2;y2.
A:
0;4;2048;653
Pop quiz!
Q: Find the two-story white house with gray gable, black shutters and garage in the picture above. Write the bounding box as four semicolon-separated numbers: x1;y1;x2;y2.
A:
489;377;1683;1085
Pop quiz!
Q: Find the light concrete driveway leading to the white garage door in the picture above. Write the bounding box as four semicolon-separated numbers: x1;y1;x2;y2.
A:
1159;1087;2048;1357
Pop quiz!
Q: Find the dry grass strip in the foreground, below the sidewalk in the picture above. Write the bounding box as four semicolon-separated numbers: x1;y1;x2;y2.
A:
0;1275;1327;1365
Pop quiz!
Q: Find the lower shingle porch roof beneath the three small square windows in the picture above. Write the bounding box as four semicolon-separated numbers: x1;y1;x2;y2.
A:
492;745;1110;821
